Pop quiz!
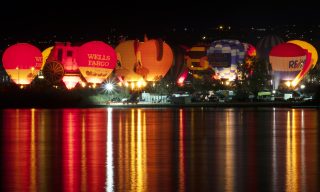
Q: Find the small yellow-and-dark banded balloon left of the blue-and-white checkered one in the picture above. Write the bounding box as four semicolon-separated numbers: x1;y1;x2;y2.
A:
186;46;209;71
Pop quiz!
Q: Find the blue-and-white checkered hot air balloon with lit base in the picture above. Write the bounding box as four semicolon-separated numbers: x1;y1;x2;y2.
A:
207;40;245;81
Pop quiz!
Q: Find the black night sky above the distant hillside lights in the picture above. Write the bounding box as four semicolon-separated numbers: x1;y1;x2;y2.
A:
0;0;320;37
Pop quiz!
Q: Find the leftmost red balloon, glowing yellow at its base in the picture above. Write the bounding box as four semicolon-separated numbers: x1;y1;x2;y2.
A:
2;43;42;85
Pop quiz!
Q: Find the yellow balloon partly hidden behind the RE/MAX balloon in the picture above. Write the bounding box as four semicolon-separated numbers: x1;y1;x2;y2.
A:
288;40;318;86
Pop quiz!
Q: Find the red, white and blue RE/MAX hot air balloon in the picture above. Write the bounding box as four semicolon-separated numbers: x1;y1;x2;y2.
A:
269;43;308;89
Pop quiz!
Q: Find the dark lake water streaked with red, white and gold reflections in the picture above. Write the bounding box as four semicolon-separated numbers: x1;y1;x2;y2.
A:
0;108;320;192
